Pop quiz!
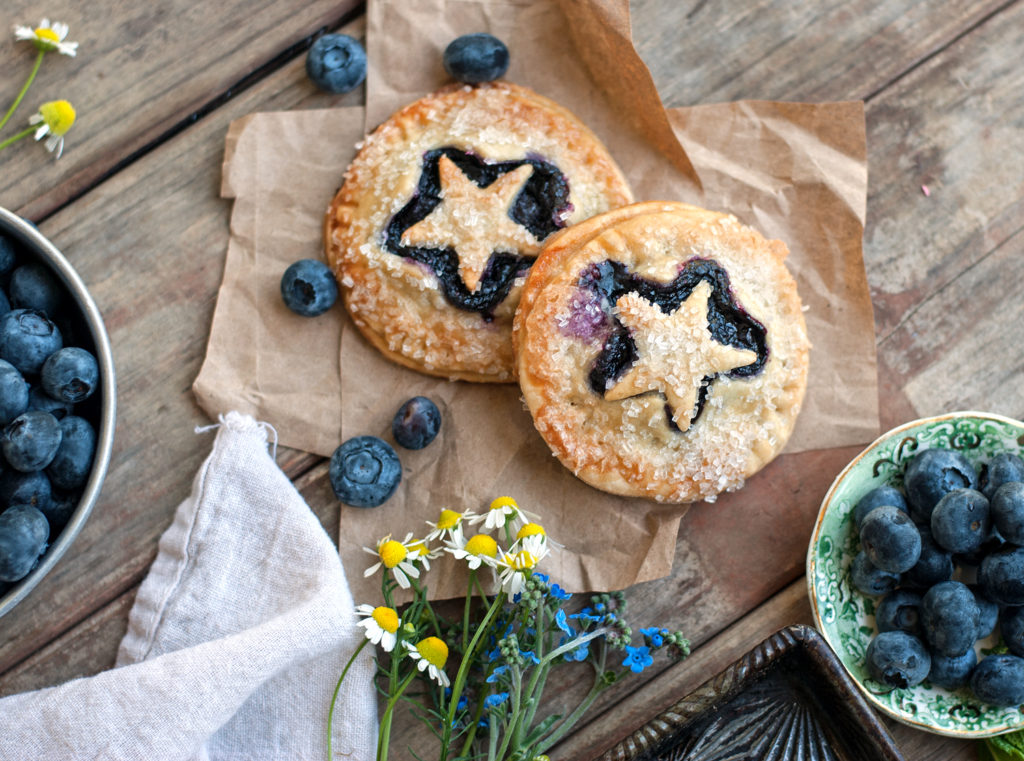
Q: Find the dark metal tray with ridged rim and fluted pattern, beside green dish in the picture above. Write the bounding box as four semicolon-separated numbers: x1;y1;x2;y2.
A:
601;625;903;761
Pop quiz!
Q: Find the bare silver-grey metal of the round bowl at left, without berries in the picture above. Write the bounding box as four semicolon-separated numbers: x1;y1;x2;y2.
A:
0;208;117;616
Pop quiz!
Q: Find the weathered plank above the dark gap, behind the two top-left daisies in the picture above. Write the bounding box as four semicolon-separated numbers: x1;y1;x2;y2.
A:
0;0;361;220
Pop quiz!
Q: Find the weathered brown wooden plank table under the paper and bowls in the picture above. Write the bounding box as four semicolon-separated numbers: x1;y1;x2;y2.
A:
0;0;1024;761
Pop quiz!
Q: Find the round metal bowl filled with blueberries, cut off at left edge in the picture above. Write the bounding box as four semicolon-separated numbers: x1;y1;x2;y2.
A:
0;208;116;616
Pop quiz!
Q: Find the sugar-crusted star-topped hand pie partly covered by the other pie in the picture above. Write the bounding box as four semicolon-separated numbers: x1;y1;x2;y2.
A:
325;83;632;382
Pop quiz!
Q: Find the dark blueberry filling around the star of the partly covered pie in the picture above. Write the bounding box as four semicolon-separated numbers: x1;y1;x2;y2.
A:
384;146;569;320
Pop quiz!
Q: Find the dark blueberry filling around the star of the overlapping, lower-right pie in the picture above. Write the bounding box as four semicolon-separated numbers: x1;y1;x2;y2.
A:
579;258;768;430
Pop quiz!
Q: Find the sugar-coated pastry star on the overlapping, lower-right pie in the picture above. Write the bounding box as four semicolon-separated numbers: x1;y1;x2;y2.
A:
604;280;758;430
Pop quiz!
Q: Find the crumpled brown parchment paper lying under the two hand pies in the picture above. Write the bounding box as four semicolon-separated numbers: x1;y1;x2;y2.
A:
195;0;879;601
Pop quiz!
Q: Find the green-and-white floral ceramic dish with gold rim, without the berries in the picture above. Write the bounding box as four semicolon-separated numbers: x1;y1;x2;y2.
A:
807;412;1024;738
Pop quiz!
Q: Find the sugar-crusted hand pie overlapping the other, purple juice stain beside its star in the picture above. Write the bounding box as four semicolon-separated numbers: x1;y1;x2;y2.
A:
513;202;810;503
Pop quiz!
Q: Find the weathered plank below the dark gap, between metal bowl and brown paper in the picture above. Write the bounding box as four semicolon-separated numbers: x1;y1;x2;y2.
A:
0;20;361;681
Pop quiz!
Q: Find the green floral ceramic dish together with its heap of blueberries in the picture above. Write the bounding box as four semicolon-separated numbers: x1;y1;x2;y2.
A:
807;412;1024;737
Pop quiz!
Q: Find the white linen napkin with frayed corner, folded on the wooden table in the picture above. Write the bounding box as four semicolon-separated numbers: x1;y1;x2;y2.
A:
0;413;377;761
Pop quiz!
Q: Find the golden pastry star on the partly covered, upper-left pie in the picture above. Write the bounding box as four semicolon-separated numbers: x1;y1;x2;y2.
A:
401;155;541;292
